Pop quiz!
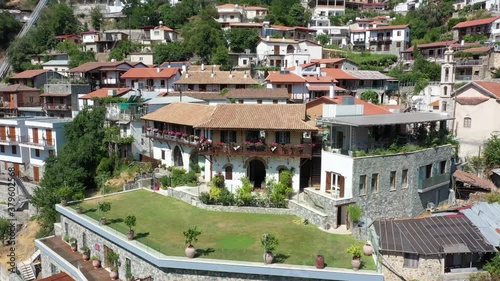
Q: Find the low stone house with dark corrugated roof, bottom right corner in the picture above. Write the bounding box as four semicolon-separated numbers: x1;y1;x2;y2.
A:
372;212;498;281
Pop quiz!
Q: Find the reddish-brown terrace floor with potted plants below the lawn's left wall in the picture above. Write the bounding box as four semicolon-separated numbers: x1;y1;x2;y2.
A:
40;236;119;281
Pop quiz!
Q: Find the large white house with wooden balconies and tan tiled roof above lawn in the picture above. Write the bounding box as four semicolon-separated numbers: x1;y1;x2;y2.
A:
143;103;317;192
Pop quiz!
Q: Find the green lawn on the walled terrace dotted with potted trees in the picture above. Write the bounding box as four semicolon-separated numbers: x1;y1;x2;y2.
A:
77;190;375;269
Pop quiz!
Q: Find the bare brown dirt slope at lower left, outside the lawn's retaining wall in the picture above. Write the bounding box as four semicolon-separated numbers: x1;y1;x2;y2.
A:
0;221;40;267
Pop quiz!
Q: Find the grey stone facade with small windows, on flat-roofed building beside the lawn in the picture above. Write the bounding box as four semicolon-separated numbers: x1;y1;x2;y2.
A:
352;145;452;220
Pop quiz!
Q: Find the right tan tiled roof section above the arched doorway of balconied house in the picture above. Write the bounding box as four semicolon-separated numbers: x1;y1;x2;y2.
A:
192;104;317;131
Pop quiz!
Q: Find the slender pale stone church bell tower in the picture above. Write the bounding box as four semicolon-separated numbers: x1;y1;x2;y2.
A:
439;47;456;116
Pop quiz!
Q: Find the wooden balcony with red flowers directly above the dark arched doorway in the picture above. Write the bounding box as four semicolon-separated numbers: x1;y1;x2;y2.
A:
199;142;313;158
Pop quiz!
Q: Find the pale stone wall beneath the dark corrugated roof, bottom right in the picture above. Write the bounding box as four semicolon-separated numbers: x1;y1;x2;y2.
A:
383;252;444;281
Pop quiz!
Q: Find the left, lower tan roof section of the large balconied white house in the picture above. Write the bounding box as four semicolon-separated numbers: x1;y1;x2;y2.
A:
142;102;217;126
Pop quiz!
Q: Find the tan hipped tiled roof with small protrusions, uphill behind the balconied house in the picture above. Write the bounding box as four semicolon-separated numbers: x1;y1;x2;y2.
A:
174;70;259;85
